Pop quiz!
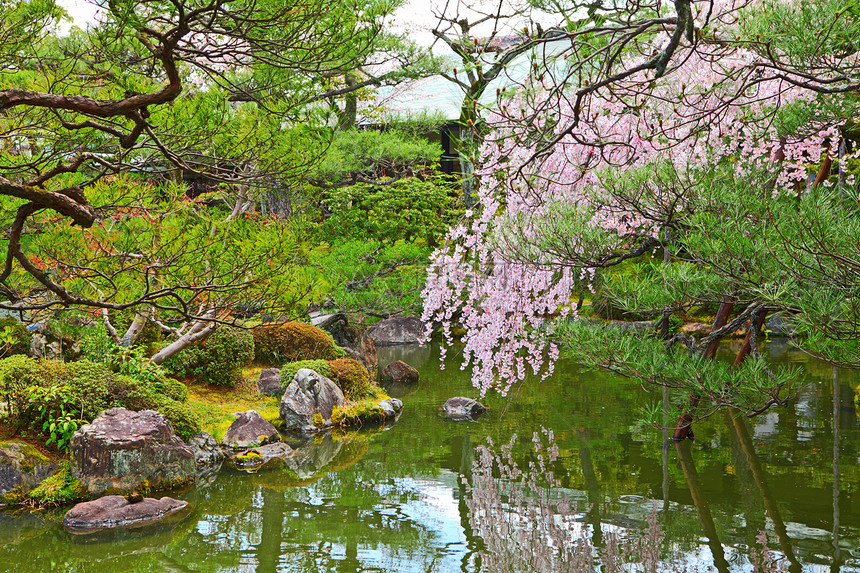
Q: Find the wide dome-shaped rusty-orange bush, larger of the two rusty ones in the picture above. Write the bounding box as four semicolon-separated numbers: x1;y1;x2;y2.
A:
253;322;344;366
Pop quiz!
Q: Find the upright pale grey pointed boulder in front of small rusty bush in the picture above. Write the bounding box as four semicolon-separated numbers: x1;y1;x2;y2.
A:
280;368;345;432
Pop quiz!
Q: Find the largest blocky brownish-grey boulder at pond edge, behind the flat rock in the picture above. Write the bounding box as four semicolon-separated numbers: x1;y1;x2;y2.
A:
71;408;197;495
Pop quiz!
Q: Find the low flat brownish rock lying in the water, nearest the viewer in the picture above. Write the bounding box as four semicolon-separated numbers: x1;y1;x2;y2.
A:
63;495;191;534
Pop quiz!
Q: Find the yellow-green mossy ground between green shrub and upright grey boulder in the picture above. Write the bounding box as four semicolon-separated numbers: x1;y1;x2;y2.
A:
188;366;280;441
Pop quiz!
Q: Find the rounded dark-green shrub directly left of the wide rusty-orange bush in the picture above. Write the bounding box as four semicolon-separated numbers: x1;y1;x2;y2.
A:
165;326;254;387
